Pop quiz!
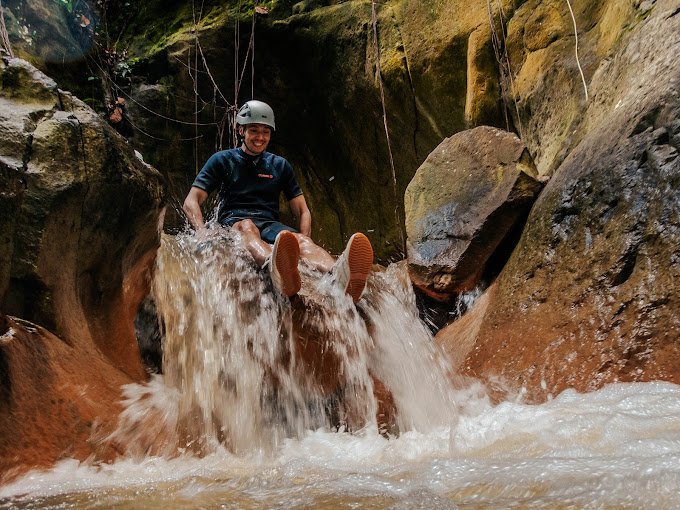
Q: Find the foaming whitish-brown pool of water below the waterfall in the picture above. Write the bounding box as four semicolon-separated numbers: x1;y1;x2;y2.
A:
0;383;680;509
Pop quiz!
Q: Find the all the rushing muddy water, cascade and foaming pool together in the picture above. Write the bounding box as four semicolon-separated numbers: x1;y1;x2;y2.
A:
0;231;680;509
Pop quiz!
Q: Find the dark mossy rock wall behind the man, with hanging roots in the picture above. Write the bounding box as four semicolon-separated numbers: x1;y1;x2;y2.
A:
75;0;505;261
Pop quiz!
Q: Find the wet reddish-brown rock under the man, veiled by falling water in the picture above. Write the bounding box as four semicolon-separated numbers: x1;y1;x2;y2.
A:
147;233;398;453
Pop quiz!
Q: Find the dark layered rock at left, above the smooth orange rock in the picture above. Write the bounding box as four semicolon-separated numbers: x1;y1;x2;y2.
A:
0;59;162;378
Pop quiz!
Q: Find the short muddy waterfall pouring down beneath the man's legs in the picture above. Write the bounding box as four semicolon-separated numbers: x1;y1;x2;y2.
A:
106;228;457;456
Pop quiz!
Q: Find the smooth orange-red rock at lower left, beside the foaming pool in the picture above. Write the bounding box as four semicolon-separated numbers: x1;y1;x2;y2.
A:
0;314;124;482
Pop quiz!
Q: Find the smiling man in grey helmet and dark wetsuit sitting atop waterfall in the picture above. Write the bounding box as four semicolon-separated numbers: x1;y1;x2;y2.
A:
183;100;373;302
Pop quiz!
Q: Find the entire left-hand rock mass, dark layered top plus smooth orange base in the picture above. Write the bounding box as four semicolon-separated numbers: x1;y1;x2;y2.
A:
0;59;163;478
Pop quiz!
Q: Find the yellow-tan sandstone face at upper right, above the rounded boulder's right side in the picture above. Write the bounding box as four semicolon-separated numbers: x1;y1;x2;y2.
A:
496;0;660;175
